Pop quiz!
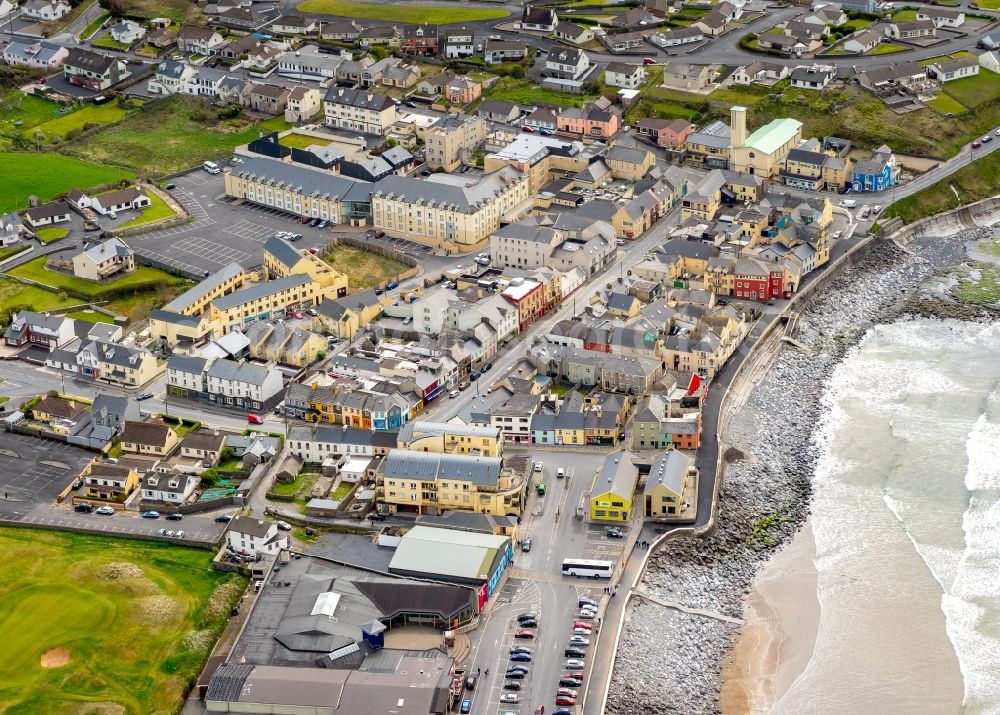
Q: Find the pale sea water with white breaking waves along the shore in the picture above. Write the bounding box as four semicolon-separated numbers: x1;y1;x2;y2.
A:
773;320;1000;715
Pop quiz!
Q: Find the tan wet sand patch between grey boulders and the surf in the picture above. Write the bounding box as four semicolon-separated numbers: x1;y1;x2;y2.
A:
719;521;820;715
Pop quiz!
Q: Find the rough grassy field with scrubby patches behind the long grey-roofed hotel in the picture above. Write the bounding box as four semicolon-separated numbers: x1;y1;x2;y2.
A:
67;96;291;176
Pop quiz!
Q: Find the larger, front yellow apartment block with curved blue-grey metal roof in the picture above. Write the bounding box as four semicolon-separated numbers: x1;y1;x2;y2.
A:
376;449;524;516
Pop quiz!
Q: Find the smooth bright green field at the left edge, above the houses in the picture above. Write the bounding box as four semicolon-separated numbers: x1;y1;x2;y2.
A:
0;152;135;212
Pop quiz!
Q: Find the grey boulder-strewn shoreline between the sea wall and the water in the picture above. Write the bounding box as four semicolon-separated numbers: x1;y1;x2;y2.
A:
607;229;996;715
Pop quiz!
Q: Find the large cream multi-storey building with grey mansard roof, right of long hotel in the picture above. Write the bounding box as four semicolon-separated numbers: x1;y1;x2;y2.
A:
371;167;531;250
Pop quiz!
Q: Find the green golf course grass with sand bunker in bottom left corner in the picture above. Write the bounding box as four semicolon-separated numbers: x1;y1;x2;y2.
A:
0;517;245;714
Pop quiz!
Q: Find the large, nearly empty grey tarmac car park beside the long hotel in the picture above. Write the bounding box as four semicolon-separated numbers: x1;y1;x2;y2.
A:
126;169;331;278
